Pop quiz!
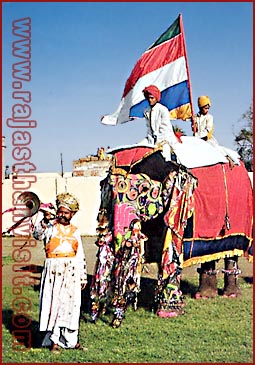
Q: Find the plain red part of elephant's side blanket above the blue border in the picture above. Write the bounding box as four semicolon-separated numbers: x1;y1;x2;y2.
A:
191;163;253;239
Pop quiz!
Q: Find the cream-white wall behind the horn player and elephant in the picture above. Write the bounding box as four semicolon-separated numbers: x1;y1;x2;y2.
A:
2;168;253;236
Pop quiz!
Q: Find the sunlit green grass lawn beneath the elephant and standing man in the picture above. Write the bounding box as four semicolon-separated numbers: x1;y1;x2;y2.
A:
2;278;253;363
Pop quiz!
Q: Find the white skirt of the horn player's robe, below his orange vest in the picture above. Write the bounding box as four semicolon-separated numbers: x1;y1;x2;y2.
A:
40;257;81;348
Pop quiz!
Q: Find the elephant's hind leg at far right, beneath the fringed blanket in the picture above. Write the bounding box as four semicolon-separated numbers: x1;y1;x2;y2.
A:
222;256;241;298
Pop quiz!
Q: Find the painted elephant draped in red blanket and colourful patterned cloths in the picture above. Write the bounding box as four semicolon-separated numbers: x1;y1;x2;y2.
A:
91;141;252;327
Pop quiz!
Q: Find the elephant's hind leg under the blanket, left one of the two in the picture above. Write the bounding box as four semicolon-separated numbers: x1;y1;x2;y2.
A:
195;261;218;299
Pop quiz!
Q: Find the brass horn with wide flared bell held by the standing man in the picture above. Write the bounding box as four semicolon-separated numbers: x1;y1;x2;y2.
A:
2;191;40;234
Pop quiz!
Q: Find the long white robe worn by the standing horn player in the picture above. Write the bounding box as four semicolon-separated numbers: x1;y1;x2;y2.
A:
33;223;87;348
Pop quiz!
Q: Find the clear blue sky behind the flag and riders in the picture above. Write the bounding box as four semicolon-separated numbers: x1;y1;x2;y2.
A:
2;2;253;172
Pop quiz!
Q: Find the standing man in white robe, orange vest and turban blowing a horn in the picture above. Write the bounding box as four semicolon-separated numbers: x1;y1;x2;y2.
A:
33;193;87;353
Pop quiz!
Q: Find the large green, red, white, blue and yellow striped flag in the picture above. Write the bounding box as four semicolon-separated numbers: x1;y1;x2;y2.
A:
101;14;193;125
